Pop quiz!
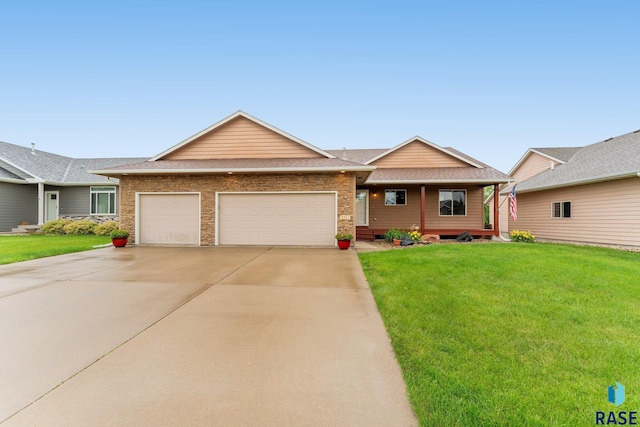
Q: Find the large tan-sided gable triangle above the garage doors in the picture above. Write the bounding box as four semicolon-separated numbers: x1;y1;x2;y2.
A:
163;117;322;160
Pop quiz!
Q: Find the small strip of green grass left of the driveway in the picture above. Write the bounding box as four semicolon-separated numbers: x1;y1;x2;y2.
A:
0;235;111;264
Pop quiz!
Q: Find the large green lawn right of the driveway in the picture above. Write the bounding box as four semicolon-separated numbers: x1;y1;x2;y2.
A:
360;243;640;426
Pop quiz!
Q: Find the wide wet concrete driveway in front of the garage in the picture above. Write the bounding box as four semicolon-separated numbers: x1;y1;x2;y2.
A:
0;247;417;427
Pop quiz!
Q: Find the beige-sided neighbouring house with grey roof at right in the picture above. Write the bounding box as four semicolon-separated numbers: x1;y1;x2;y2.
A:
502;130;640;246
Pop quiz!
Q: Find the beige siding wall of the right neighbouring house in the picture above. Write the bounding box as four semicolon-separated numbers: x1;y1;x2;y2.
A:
509;178;640;246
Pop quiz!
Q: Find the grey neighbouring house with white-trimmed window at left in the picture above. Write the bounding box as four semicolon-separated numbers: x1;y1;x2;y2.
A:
0;142;145;232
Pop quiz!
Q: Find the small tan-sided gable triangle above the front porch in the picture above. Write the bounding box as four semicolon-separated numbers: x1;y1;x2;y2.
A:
372;141;469;168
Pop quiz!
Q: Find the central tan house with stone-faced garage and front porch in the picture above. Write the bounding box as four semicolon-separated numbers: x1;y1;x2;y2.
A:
93;111;509;246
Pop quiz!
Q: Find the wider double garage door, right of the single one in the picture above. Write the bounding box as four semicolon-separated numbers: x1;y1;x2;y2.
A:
218;193;336;246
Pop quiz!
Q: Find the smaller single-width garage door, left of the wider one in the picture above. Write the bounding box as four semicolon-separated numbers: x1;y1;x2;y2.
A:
138;194;200;245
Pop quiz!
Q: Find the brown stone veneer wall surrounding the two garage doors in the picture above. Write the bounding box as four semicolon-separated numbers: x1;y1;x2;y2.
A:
120;173;356;246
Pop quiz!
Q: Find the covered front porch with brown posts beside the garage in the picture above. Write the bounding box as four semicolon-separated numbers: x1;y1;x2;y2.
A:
355;183;500;240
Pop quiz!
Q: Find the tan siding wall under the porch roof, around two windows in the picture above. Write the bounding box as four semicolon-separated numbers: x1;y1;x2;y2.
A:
358;185;484;230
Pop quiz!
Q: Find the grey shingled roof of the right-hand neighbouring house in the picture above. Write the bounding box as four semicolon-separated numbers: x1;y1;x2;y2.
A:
517;130;640;193
